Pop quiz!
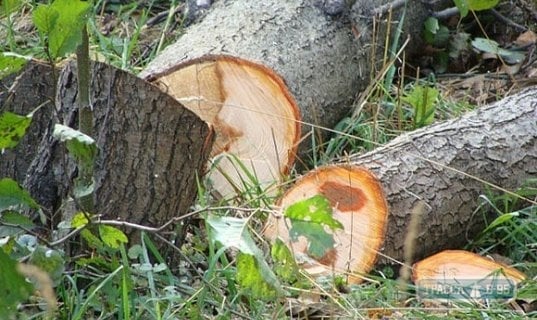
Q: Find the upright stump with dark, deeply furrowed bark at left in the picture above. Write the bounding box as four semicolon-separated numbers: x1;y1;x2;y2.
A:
0;62;214;235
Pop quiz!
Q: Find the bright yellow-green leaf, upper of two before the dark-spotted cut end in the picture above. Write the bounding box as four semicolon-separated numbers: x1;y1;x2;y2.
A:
284;195;343;229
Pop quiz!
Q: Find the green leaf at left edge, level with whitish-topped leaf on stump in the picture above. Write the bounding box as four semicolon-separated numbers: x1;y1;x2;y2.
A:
0;112;32;150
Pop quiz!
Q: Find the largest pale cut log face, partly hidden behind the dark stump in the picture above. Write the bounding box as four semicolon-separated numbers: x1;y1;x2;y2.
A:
144;55;300;196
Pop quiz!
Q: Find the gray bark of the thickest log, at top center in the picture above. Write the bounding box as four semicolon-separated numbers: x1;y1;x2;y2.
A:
140;0;440;155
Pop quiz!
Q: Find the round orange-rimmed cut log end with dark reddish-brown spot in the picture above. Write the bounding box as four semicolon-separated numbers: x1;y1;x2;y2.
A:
265;166;388;283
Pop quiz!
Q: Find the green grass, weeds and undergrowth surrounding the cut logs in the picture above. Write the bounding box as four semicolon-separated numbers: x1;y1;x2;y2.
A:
0;0;537;319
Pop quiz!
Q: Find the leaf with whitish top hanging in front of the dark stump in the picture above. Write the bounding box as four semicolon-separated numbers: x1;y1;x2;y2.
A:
52;124;97;166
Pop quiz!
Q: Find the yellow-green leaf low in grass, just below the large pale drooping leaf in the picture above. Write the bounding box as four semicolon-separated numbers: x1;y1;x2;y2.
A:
237;253;277;300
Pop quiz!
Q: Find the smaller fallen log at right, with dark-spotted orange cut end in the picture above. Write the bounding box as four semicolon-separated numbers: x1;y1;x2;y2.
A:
266;88;537;282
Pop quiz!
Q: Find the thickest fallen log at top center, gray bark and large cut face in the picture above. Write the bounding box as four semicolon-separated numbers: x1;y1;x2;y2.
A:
140;0;440;195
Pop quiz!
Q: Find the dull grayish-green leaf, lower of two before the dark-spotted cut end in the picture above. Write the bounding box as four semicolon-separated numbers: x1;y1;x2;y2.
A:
289;220;335;259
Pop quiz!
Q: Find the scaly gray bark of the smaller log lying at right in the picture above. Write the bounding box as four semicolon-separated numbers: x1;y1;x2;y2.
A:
346;88;537;263
